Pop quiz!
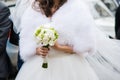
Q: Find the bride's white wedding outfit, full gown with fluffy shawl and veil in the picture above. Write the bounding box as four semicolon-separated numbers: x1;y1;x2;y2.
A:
15;0;120;80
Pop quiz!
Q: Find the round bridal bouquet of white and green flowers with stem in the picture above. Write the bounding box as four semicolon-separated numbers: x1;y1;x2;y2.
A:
34;24;58;68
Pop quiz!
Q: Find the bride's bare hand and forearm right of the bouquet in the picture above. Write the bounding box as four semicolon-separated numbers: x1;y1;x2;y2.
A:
53;42;74;54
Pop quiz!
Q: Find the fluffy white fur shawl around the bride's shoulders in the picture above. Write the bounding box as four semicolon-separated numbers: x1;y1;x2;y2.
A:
19;0;95;61
